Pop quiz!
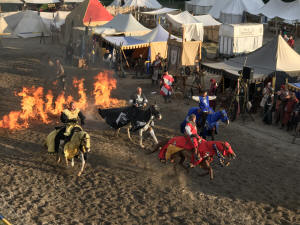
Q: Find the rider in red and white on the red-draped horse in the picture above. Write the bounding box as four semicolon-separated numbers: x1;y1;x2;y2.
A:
184;114;202;165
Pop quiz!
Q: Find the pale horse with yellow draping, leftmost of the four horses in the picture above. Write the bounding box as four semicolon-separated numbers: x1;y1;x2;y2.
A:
45;129;91;176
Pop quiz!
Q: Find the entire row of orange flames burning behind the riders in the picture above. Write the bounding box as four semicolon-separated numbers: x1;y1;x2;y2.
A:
0;72;126;130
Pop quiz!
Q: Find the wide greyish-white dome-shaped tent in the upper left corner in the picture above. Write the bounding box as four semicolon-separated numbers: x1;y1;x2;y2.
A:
6;10;50;38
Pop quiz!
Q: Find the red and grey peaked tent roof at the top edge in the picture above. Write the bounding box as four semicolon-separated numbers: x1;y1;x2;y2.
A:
66;0;113;27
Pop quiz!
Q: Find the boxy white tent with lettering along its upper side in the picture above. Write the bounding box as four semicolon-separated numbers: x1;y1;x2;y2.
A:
219;23;264;56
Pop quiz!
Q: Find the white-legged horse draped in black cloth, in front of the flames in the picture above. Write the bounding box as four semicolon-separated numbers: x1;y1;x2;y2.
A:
98;104;162;148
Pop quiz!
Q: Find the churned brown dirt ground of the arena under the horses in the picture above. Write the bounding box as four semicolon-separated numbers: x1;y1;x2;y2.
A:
0;39;300;225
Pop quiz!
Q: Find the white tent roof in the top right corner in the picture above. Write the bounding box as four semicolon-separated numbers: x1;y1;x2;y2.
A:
258;0;300;20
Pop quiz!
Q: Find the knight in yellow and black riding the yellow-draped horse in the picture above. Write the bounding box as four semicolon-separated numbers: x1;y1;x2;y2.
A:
55;102;85;152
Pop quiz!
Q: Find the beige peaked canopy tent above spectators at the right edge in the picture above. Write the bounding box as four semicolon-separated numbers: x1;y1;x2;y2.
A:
202;35;300;87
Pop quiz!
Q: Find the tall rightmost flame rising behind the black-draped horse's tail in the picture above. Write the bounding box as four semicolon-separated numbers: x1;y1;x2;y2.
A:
93;73;126;108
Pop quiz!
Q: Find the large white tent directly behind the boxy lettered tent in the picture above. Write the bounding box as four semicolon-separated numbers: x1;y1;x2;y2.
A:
220;0;264;24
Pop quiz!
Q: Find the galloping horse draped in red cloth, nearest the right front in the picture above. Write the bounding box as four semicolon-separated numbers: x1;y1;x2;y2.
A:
152;136;236;180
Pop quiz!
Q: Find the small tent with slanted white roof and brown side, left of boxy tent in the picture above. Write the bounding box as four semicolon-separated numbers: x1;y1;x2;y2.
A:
194;15;221;42
